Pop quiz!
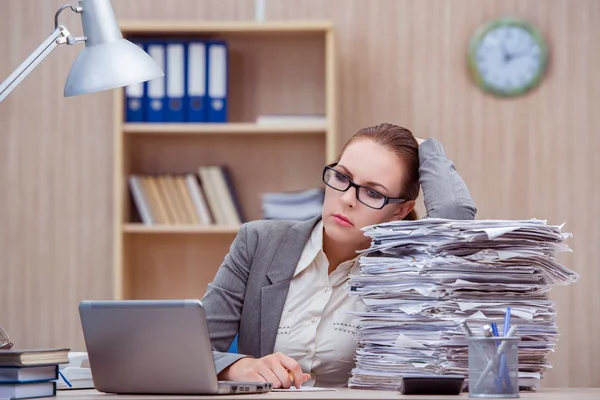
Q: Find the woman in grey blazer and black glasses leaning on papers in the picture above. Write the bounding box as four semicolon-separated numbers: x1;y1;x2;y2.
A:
202;124;476;388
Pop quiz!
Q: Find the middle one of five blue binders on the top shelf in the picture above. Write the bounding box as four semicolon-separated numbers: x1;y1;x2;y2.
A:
165;41;186;122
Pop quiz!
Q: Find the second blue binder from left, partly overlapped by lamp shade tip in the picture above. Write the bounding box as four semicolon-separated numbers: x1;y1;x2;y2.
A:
144;42;169;122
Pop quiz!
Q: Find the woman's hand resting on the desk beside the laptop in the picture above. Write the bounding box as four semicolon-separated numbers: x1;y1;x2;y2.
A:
219;353;310;389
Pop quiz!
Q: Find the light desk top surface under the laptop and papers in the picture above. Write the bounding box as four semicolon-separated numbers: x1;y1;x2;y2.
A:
57;388;600;400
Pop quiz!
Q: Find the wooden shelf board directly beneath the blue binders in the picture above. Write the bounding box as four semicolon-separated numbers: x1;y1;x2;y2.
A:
123;122;327;135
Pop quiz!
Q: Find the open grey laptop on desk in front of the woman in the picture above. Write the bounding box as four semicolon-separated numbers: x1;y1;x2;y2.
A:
79;300;272;395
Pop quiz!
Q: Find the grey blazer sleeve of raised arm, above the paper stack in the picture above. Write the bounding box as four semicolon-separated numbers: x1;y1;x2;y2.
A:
419;138;477;220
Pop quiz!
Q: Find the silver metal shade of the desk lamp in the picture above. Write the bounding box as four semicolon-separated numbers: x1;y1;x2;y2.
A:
64;0;164;97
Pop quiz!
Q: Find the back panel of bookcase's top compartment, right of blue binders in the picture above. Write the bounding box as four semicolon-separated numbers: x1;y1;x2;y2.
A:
122;32;325;122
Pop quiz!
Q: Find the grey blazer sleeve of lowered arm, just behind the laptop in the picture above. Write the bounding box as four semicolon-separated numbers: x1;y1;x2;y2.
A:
202;224;252;374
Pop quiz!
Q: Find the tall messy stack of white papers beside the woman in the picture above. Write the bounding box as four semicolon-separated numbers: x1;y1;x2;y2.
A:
349;219;578;390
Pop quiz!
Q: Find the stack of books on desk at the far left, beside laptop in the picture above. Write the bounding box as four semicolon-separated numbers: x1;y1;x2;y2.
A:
0;349;69;399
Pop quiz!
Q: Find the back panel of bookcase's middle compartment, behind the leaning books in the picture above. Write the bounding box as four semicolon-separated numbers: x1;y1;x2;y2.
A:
125;134;325;222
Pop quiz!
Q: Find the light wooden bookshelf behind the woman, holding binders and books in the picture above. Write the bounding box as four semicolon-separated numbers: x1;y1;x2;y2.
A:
114;21;337;299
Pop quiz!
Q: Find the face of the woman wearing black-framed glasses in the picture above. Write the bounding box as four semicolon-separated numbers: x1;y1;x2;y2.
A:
322;138;414;247
